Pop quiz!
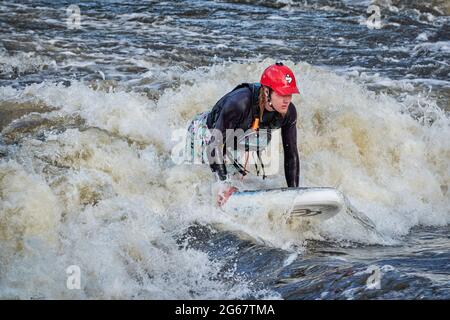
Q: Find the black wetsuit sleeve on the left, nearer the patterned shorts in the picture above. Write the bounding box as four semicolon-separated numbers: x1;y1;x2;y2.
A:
206;90;251;180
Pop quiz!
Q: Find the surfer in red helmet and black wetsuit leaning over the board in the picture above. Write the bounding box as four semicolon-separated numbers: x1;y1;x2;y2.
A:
187;62;300;206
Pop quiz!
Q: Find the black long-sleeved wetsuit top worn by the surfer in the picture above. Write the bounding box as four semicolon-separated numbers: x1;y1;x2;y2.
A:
206;83;300;187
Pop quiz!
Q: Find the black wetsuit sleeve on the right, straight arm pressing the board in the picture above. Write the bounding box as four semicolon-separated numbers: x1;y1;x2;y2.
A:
281;104;300;187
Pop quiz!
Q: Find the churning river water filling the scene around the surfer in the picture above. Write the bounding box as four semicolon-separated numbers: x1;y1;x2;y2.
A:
0;0;450;299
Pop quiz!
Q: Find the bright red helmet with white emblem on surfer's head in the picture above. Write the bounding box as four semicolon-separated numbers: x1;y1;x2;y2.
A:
260;62;299;96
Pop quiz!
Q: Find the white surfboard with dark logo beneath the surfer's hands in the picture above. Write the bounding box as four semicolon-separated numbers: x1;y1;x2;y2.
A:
223;187;345;221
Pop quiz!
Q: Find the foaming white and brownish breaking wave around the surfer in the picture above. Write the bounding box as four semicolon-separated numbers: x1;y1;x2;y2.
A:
0;60;450;299
